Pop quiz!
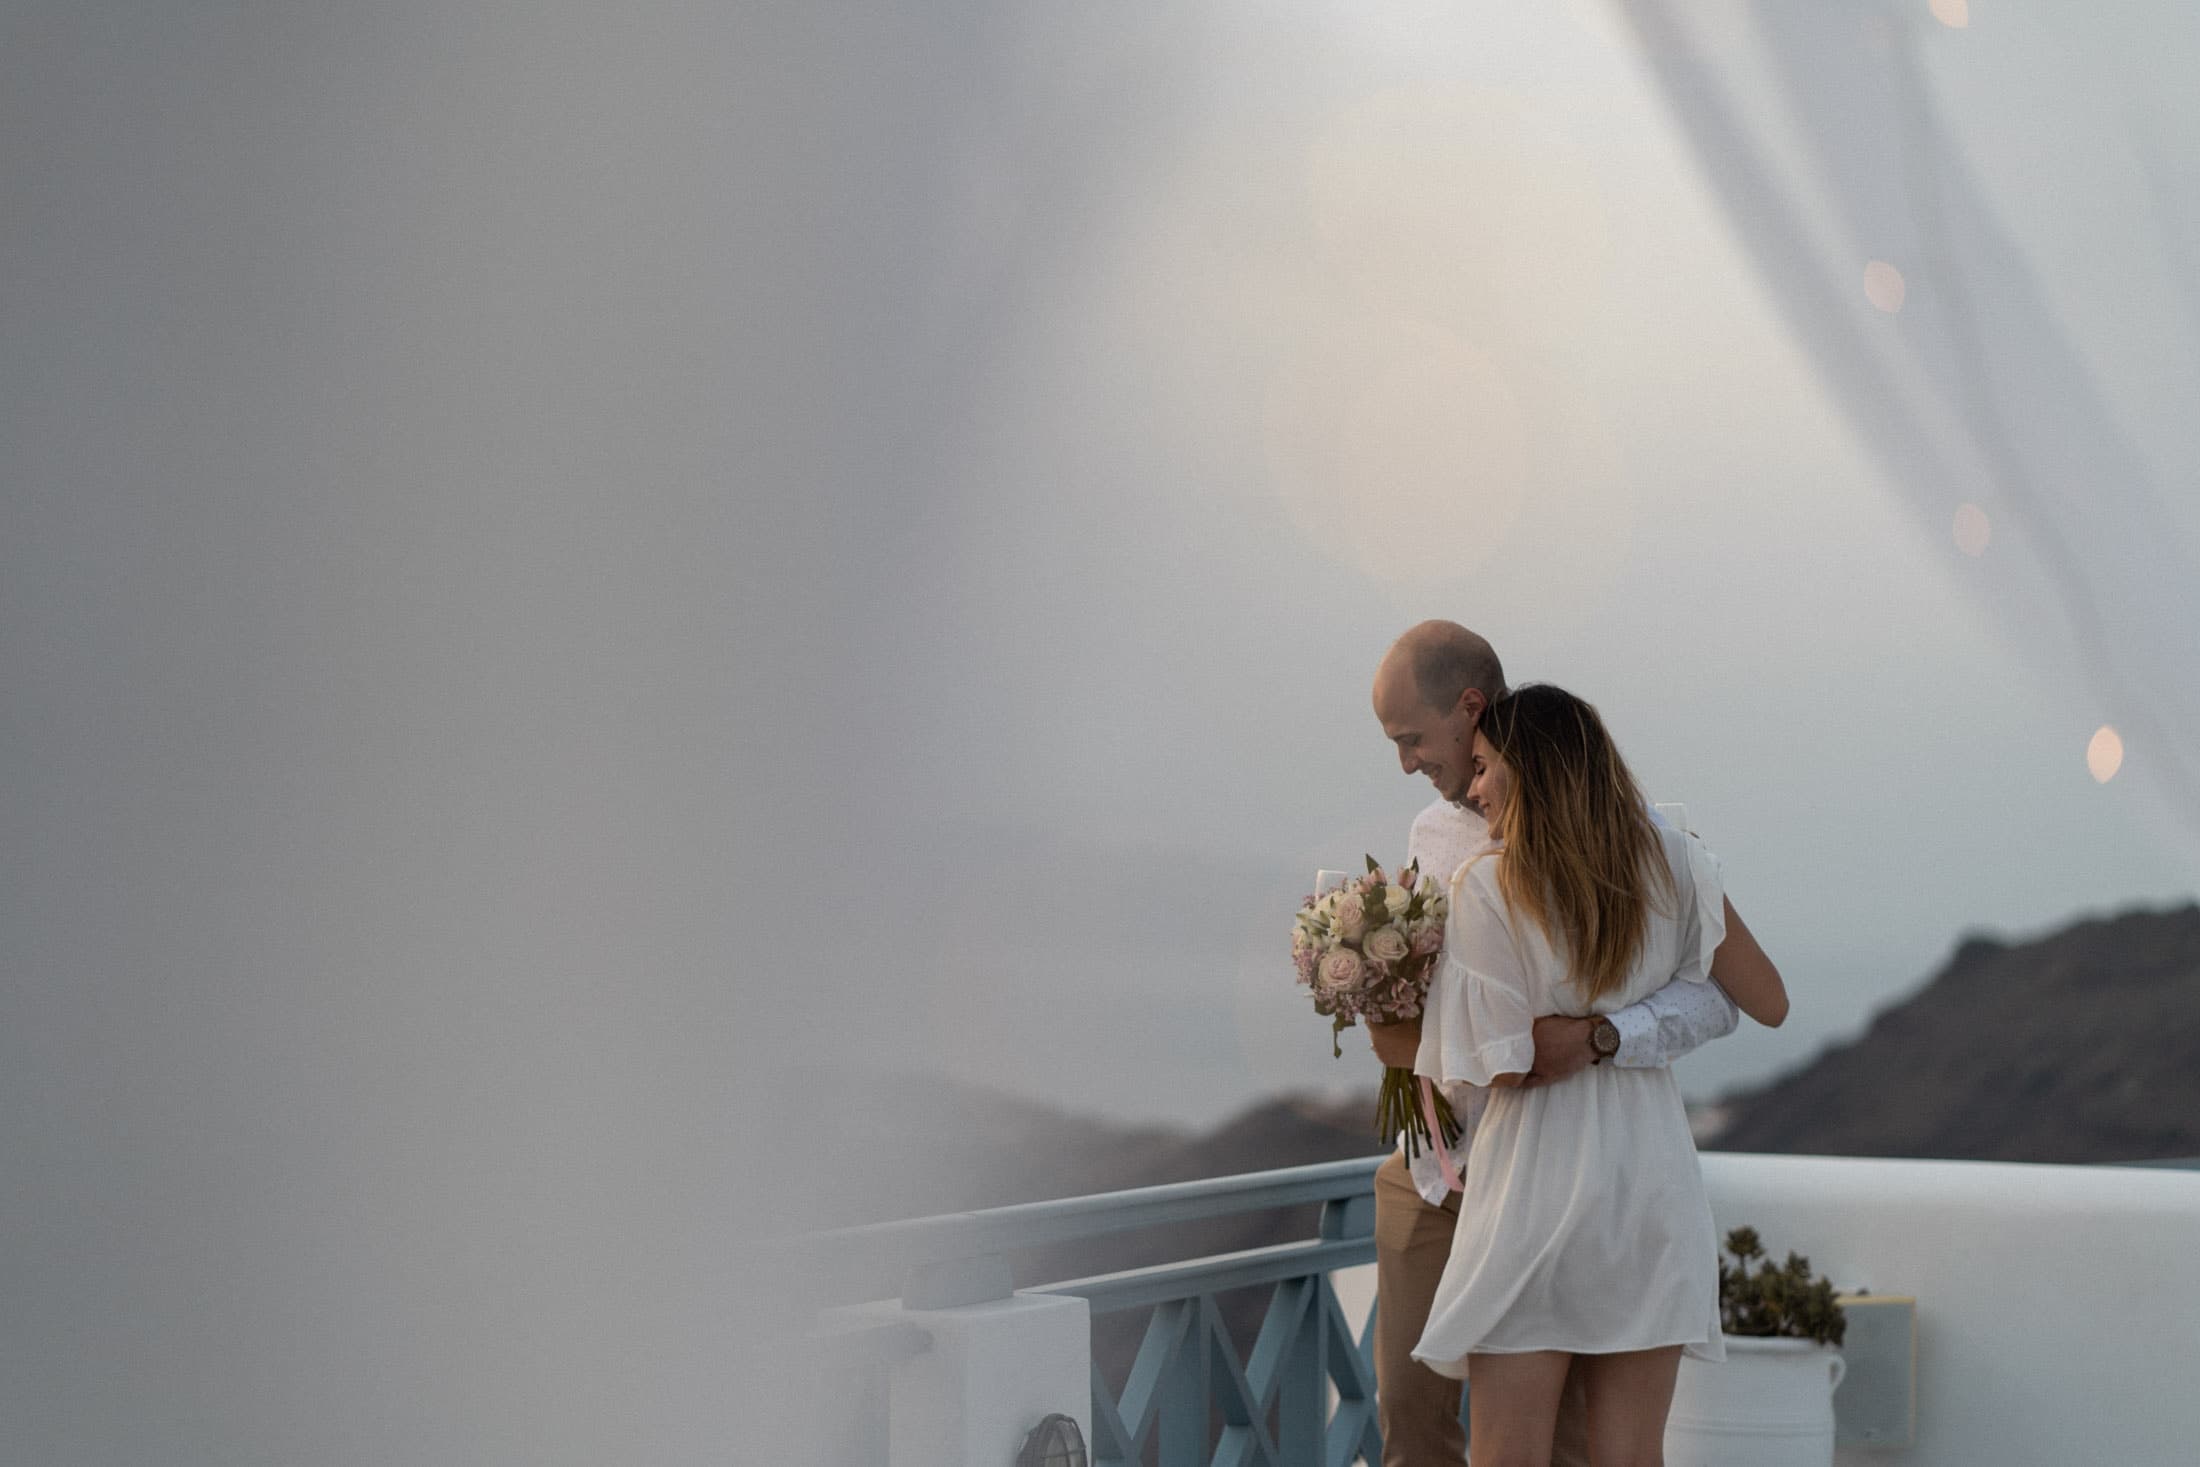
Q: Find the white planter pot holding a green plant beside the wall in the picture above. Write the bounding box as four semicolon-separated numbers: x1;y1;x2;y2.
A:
1665;1335;1846;1467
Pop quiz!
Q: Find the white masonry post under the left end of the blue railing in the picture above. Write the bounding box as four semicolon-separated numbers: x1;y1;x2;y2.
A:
862;1293;1091;1467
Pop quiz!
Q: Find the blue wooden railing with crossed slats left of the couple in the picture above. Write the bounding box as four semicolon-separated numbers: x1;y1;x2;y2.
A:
790;1157;1382;1467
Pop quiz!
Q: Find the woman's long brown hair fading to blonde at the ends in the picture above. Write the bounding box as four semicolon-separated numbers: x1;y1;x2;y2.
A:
1481;684;1674;1003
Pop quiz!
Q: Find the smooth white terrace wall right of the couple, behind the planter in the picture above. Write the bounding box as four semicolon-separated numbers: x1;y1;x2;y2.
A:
1703;1152;2200;1467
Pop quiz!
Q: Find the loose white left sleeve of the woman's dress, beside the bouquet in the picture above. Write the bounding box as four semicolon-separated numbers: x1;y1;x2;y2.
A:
1412;867;1536;1087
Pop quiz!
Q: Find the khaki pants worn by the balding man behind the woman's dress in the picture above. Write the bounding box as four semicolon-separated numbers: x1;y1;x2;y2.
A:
1375;1152;1588;1467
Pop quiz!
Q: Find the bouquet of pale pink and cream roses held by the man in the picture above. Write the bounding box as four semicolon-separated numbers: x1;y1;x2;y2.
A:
1291;856;1459;1155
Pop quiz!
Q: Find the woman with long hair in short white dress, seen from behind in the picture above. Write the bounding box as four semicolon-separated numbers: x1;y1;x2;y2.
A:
1415;684;1786;1467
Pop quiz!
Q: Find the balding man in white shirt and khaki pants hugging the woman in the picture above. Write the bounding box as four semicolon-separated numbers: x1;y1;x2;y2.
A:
1368;622;1740;1467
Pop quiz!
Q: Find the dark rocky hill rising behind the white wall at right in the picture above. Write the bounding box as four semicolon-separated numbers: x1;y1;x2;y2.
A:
1707;906;2200;1161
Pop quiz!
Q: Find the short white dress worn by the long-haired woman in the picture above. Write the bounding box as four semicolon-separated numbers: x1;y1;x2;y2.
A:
1412;827;1725;1377
